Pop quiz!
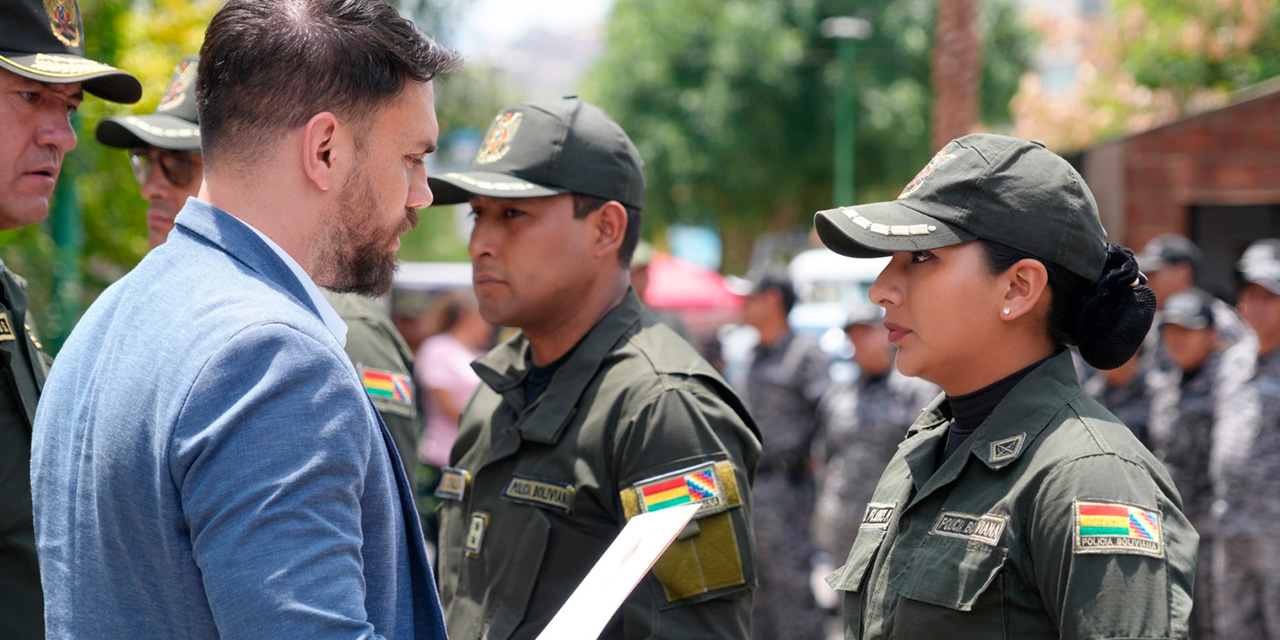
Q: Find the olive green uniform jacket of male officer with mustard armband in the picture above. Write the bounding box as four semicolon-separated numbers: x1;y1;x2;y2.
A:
436;291;760;640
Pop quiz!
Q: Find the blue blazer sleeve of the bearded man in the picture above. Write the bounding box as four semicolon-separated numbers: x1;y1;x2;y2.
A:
170;325;380;639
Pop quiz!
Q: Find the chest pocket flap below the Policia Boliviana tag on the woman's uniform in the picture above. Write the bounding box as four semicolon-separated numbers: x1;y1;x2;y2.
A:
890;538;1009;611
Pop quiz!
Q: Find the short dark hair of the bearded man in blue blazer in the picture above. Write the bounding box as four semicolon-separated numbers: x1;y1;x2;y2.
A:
196;0;462;165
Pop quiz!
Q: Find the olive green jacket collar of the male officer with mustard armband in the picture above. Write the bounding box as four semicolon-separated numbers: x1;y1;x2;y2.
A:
471;289;643;444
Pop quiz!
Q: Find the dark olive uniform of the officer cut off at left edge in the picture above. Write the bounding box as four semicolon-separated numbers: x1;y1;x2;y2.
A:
0;262;51;640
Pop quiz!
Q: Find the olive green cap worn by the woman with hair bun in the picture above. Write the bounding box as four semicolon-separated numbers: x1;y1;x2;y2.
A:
814;133;1107;282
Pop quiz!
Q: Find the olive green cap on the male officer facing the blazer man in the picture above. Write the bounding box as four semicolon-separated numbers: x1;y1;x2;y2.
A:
428;96;645;210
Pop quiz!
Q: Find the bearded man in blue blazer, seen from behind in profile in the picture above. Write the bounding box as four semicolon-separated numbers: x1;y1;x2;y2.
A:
31;0;458;639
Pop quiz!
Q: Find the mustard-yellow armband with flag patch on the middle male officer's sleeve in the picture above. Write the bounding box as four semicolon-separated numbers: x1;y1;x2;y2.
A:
620;461;746;602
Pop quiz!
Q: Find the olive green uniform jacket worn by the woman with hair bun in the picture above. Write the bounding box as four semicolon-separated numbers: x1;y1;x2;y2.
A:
828;352;1198;640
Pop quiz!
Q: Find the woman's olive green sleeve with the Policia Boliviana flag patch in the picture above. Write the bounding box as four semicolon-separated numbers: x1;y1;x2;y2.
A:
1023;454;1199;640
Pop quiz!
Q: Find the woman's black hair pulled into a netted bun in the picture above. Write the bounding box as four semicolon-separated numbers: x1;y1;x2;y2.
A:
978;239;1156;369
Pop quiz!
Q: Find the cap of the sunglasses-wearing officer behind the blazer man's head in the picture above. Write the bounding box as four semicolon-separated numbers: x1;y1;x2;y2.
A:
96;55;200;151
